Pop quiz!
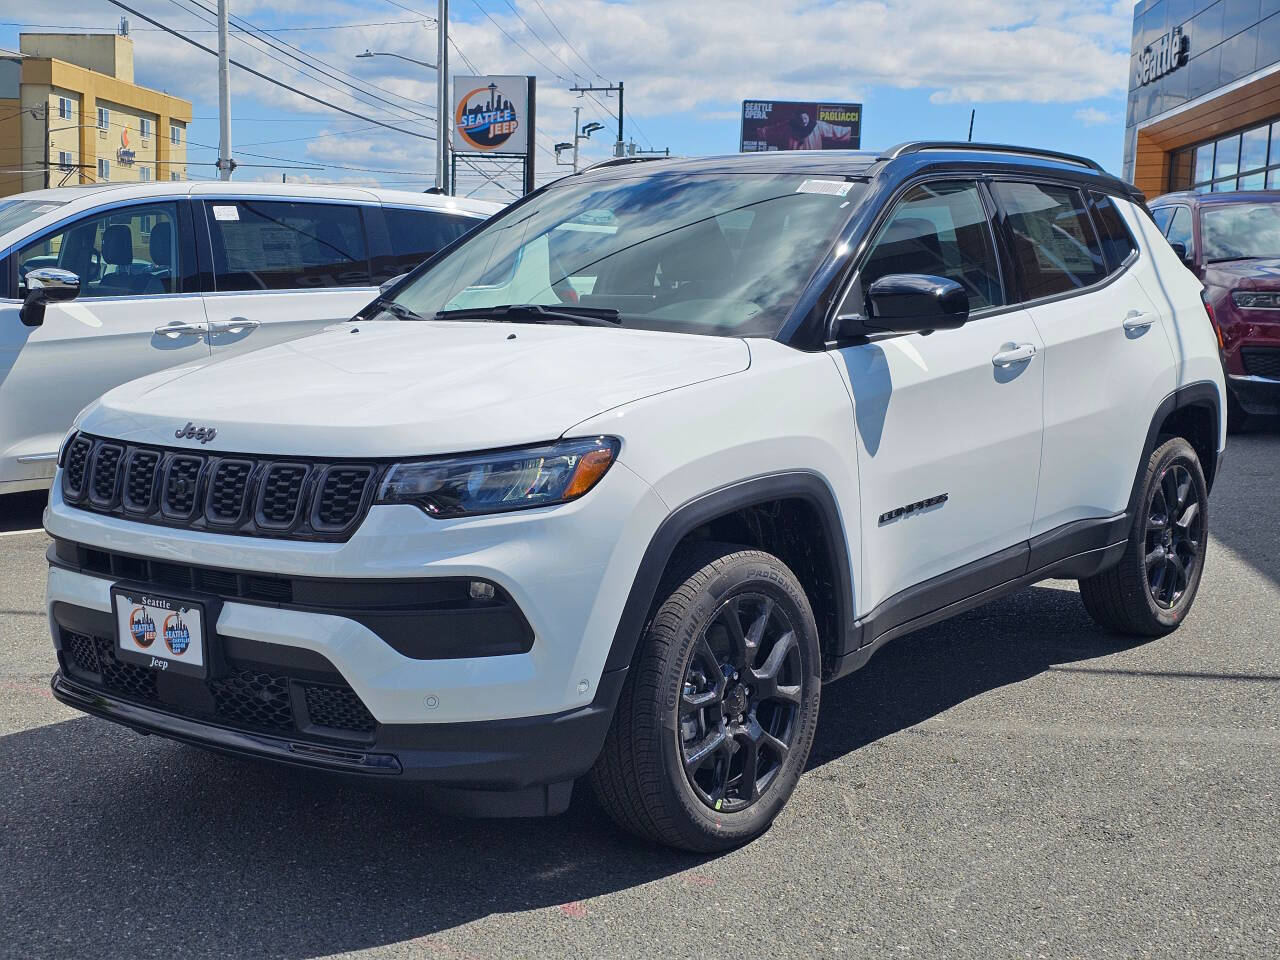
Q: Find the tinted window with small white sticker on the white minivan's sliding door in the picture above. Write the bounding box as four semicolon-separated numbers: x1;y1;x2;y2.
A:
205;200;370;291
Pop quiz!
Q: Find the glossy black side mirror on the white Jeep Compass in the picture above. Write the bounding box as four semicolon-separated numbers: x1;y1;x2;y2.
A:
828;274;969;340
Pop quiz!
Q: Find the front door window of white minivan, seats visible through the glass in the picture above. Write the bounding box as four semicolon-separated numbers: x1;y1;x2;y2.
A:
18;204;186;298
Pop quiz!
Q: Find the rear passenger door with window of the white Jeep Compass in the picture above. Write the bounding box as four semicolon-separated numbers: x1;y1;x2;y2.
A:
992;180;1174;536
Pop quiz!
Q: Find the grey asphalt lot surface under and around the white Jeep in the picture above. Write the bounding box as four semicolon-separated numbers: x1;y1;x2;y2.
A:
0;425;1280;960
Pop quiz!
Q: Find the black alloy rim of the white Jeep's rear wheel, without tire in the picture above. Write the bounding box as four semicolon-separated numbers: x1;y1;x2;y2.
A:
1146;461;1203;611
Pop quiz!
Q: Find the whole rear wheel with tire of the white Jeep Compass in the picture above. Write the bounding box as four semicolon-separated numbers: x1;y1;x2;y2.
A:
1080;436;1208;636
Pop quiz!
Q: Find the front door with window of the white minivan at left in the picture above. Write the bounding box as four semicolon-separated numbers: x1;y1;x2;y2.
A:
0;200;209;483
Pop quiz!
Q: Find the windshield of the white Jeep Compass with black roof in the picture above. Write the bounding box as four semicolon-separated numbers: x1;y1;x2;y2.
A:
384;173;863;337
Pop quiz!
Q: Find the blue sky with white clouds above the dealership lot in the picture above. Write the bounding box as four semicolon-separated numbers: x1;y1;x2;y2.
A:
0;0;1133;196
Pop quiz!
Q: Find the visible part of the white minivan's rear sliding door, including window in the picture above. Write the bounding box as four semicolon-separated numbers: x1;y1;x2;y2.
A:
197;196;378;357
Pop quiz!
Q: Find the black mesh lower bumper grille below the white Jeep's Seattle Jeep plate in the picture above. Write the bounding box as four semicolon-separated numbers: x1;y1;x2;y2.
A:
61;630;378;741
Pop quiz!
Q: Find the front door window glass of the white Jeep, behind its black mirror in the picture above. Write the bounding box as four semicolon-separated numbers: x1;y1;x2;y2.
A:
859;182;1005;310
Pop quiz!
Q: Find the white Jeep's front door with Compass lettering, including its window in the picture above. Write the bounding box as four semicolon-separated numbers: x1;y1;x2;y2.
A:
840;180;1044;616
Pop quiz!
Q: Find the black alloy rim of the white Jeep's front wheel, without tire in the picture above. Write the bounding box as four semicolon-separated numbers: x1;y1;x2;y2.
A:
676;593;804;813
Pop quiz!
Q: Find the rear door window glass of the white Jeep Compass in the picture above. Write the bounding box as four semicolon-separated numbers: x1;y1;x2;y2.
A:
992;183;1107;300
